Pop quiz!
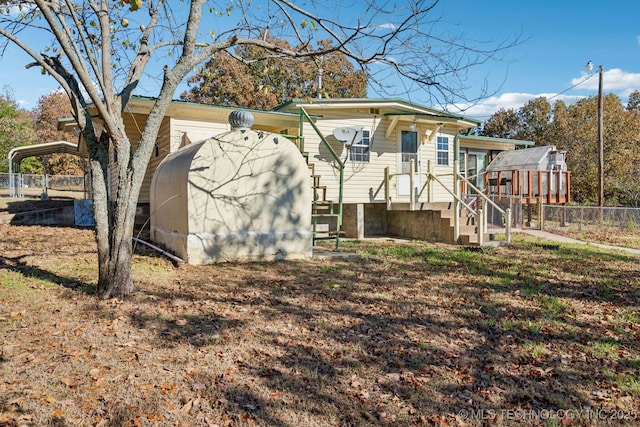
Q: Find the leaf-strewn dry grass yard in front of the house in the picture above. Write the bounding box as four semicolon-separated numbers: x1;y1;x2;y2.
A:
0;225;640;427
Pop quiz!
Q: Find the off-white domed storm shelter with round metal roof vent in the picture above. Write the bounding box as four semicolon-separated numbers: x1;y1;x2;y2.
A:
150;111;313;264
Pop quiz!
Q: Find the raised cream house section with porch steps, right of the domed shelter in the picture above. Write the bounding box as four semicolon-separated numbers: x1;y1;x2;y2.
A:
276;99;534;242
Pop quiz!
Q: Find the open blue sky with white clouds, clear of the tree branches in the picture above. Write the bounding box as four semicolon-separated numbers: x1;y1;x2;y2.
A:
0;0;640;120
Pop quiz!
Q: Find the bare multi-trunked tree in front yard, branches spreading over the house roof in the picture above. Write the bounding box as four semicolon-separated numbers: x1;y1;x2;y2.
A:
0;0;515;298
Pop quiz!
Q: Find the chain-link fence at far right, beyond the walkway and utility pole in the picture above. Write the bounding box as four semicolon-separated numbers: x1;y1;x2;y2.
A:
542;205;640;232
